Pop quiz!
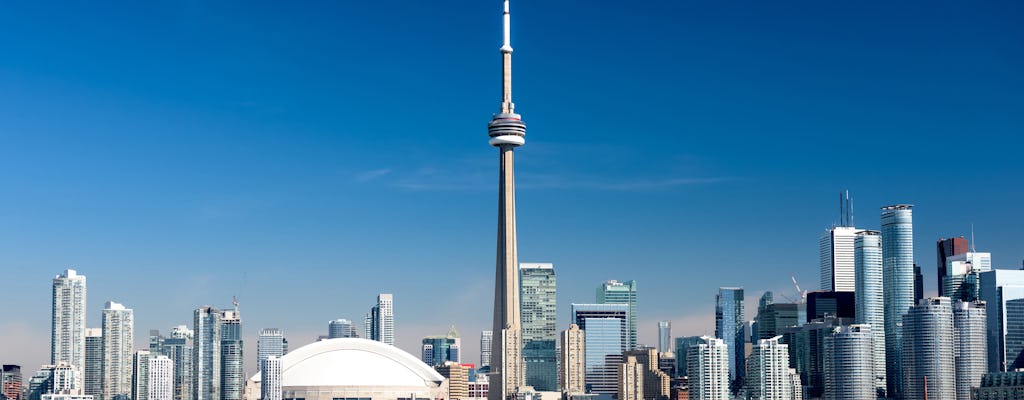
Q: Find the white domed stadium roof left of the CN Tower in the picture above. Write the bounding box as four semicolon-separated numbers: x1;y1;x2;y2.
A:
252;338;446;398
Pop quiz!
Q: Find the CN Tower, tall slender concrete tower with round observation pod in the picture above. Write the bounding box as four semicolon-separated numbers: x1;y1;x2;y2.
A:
487;0;526;400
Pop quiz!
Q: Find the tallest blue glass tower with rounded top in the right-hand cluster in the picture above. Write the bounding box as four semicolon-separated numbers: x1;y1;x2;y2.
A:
882;205;913;398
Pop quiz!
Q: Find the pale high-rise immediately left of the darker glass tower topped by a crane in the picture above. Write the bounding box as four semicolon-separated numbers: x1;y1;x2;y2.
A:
193;306;221;400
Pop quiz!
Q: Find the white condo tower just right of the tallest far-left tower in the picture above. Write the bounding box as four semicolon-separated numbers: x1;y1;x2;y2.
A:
102;302;135;400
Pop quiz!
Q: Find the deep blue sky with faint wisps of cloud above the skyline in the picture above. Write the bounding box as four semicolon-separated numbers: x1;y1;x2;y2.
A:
0;0;1024;369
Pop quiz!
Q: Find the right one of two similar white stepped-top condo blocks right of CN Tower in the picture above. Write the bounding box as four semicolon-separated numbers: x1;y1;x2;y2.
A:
744;336;799;400
